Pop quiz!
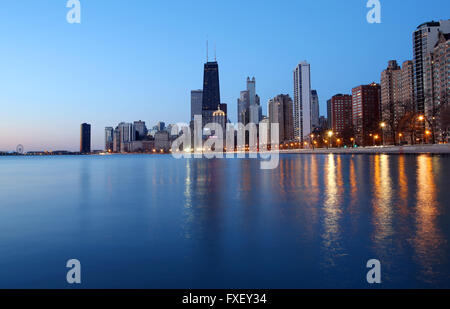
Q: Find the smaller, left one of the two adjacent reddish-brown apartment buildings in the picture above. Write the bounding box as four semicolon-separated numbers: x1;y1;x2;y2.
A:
330;94;353;135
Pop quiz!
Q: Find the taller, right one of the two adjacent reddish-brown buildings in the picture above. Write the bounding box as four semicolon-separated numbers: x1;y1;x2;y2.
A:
352;83;381;146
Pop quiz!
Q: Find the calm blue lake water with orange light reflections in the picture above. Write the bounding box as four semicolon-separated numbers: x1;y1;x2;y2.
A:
0;154;450;288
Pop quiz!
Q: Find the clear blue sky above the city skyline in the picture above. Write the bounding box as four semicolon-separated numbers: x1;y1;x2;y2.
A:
0;0;450;151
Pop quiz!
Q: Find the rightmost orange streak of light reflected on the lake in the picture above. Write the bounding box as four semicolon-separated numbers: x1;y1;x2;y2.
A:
413;155;445;283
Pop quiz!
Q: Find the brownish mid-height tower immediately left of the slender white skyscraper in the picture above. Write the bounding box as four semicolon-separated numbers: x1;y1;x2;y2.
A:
267;94;294;143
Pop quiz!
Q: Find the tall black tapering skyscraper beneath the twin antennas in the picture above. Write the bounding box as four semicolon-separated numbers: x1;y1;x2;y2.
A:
202;61;221;124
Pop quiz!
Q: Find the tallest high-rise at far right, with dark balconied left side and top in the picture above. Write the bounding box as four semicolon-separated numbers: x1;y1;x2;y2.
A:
413;19;450;114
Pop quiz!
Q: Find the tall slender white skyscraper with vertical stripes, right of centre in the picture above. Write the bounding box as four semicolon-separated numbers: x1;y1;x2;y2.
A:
294;61;312;145
